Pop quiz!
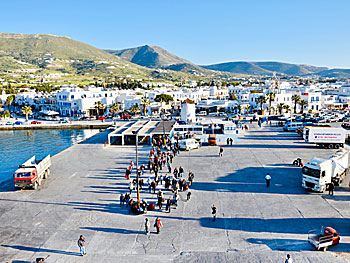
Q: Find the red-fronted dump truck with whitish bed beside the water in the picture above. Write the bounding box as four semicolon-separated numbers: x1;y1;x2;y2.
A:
13;155;51;189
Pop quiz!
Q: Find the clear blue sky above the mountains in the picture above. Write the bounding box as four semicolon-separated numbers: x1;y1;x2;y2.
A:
0;0;350;68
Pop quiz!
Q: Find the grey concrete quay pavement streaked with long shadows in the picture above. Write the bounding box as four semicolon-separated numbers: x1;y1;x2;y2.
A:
0;127;350;262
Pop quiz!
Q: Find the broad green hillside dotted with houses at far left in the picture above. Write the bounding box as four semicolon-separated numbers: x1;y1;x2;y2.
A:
0;33;149;75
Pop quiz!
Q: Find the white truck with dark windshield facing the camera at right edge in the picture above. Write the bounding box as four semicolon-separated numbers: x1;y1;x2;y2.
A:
302;149;349;192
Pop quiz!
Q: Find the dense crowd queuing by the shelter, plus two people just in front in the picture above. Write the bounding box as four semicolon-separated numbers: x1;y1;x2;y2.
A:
120;137;194;233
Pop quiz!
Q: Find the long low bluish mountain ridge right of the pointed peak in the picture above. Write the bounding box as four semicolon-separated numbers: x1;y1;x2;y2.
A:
201;61;328;76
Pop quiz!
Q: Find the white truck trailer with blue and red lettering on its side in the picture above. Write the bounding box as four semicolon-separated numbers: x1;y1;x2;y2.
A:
303;127;346;149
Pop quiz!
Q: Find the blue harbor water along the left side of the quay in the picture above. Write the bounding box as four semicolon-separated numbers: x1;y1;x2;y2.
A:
0;129;98;183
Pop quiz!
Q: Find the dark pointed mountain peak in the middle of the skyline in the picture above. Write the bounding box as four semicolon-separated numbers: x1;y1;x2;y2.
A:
106;45;215;75
